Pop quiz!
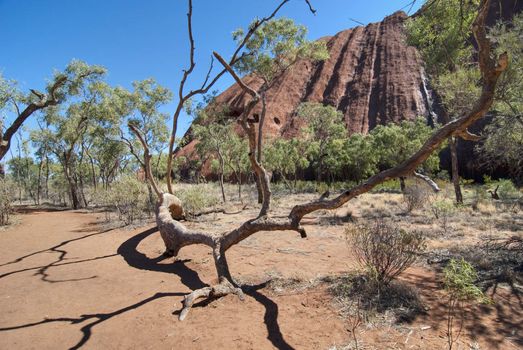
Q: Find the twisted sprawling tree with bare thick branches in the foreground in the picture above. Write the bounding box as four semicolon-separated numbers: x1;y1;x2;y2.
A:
130;0;508;320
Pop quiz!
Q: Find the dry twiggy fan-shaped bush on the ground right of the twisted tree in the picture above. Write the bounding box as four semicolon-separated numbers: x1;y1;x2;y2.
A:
346;220;426;288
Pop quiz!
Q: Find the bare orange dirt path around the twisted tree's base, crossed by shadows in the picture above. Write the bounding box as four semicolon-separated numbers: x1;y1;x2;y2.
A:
0;211;352;349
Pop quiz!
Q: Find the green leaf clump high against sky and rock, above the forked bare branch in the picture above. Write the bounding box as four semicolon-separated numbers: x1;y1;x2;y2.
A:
233;18;329;84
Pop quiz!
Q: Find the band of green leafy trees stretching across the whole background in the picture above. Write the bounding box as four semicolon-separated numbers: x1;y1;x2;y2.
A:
0;8;523;208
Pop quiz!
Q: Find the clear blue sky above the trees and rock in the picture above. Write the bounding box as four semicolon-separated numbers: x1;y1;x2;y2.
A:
0;0;422;149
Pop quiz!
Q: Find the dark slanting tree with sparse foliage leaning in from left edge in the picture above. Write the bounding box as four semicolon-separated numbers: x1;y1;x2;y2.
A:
0;60;104;176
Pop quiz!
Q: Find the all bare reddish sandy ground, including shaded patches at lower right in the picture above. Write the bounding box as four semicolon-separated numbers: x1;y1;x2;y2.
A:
0;206;523;349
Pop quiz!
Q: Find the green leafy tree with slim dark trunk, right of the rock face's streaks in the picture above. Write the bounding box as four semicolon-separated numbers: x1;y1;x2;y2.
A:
406;0;480;203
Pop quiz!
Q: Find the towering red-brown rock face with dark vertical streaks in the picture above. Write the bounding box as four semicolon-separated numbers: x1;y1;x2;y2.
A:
180;12;431;146
